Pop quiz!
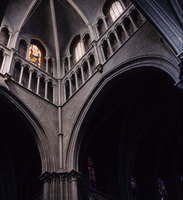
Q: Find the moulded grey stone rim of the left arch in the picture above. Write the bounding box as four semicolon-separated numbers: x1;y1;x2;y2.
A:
0;85;55;173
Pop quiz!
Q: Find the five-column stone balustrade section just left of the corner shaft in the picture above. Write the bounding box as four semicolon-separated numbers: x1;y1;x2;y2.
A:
12;53;57;103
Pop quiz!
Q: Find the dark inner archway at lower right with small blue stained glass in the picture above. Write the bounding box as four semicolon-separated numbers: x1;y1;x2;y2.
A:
130;109;183;199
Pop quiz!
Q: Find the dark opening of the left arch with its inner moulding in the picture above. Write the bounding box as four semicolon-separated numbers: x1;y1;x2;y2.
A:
0;87;54;200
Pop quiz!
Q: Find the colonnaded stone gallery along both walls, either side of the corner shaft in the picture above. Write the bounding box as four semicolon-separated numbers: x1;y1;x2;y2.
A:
0;4;146;103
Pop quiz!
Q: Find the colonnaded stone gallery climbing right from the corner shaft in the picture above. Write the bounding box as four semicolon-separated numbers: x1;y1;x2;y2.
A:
62;4;146;102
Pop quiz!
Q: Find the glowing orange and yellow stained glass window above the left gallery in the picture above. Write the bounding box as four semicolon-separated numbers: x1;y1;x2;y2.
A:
27;44;41;68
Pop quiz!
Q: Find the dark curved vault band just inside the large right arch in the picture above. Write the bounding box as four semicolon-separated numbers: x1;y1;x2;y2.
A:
72;67;183;200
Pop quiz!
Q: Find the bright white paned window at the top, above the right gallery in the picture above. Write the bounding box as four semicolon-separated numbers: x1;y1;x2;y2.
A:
109;1;123;22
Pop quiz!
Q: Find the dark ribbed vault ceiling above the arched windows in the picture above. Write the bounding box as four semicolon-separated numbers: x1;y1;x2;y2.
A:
4;0;103;55
